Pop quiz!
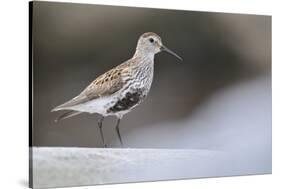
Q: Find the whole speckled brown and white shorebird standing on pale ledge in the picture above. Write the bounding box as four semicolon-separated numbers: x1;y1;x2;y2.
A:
52;32;182;147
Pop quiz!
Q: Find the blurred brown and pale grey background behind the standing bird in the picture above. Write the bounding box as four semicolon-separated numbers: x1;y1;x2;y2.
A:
33;2;271;152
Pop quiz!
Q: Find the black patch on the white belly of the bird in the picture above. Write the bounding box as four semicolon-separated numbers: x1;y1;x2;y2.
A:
107;91;144;113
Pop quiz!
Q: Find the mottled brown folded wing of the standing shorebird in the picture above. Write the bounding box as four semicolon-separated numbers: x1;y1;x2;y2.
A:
53;67;124;111
